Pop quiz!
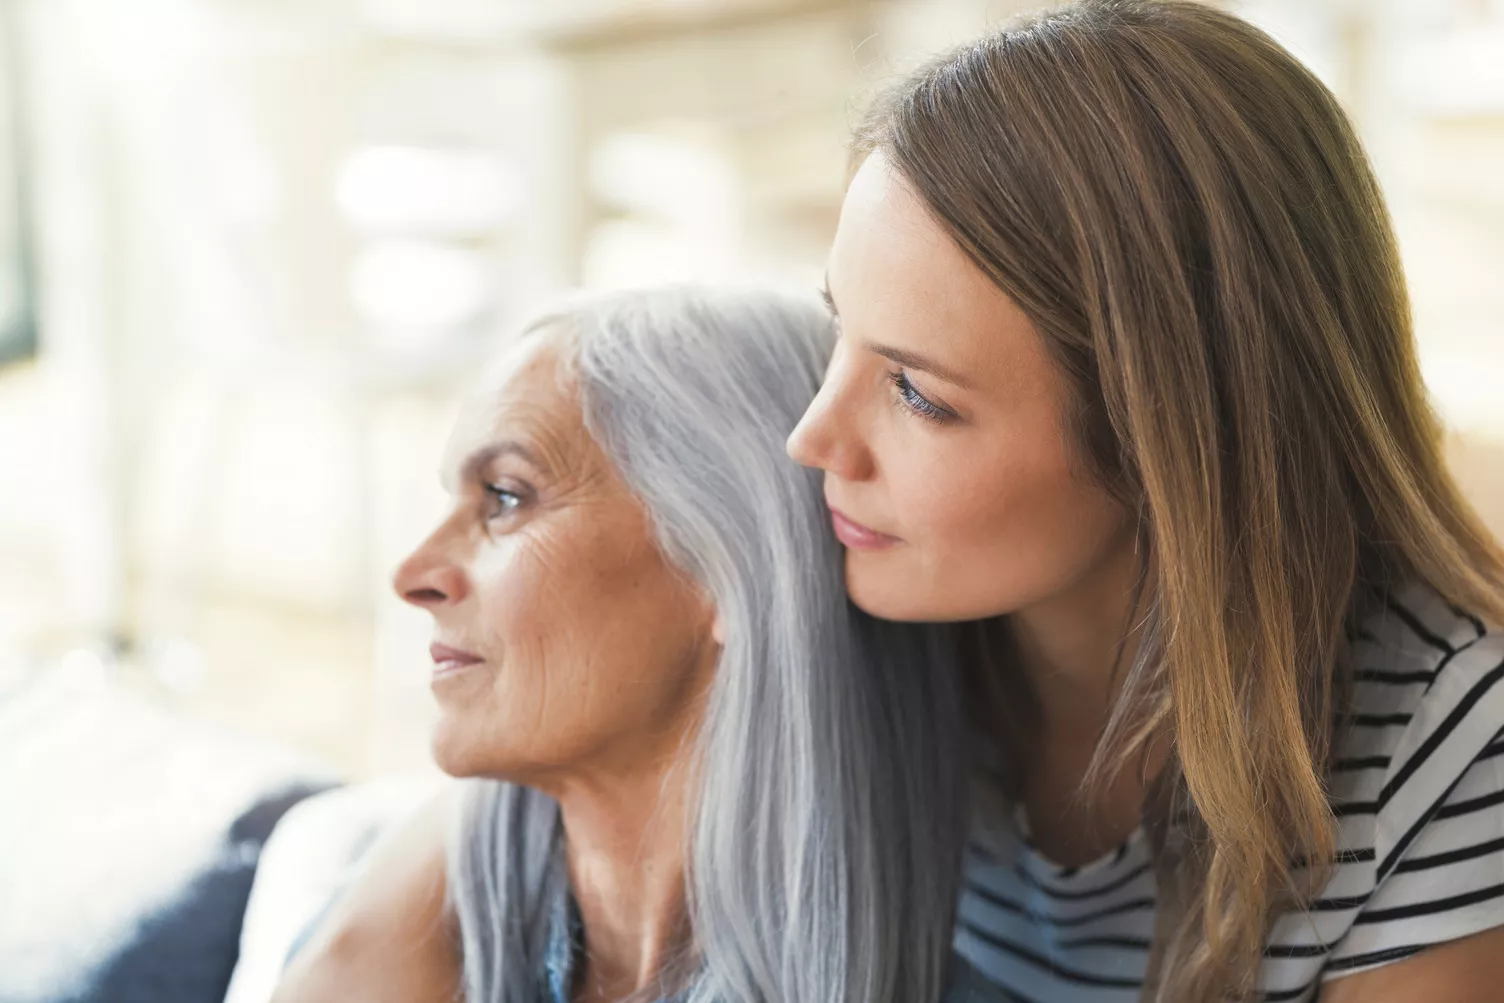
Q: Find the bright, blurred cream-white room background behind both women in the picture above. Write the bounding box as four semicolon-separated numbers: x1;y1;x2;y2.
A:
0;0;1504;777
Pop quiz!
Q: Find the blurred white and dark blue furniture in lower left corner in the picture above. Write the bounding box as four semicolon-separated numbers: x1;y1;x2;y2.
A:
0;663;337;1003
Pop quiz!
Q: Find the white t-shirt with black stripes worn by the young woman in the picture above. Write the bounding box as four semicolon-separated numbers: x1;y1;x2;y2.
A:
957;586;1504;1003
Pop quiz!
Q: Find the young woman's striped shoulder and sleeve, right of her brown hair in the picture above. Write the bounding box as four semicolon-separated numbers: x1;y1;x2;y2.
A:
1305;585;1504;979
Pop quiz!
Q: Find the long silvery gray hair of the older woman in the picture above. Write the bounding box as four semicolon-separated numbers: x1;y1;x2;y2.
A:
448;287;966;1003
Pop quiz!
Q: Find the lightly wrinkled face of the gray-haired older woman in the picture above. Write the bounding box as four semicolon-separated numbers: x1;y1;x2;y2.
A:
393;335;717;788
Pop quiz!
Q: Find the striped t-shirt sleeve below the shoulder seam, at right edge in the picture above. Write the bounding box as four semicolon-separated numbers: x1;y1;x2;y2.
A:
1322;633;1504;979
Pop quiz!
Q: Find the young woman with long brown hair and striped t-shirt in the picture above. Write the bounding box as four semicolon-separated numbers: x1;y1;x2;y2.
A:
790;0;1504;1003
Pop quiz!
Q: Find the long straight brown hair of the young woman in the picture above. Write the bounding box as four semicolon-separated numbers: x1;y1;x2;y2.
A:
857;0;1504;1003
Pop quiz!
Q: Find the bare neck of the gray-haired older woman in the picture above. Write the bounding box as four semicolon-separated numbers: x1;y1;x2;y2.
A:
559;767;692;1001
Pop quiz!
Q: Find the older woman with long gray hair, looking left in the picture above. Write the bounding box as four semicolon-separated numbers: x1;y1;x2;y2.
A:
270;289;998;1003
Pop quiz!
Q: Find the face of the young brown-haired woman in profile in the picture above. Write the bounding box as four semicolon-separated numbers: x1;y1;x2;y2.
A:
788;155;1133;621
